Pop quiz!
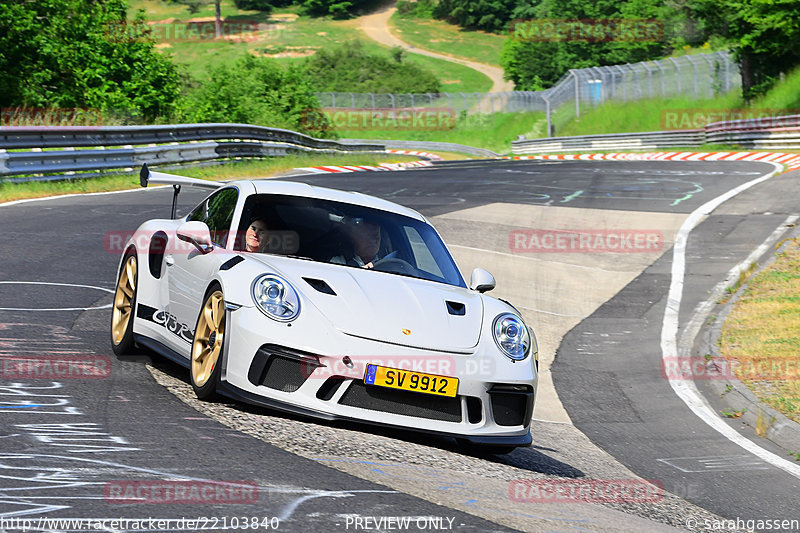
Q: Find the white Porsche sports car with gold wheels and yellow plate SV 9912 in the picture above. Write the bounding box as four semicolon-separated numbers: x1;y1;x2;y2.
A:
111;166;538;453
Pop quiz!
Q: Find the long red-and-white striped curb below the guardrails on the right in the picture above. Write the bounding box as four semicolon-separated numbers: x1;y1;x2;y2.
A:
505;152;800;172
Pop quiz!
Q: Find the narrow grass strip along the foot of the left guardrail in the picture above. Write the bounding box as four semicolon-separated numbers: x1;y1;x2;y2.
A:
0;154;419;203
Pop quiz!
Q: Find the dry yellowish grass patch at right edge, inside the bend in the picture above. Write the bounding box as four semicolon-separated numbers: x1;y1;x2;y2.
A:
720;239;800;422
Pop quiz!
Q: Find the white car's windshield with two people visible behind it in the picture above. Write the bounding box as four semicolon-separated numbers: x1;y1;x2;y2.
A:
236;194;466;287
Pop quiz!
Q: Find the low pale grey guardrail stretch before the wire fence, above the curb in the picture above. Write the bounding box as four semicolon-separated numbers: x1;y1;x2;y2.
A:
511;130;705;155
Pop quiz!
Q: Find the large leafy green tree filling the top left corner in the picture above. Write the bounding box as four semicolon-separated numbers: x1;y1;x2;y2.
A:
0;0;180;120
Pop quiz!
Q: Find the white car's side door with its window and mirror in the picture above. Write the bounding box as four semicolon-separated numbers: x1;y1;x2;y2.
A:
166;187;239;356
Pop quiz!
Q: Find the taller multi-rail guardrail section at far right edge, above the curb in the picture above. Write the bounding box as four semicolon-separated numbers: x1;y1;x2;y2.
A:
705;115;800;150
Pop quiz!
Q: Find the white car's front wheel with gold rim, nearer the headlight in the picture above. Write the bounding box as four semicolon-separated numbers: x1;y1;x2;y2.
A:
194;286;226;400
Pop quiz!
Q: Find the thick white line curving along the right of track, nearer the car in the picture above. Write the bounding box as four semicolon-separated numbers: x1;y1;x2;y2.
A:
661;163;800;478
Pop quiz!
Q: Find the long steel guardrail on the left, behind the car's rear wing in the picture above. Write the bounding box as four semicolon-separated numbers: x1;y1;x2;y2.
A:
0;124;385;176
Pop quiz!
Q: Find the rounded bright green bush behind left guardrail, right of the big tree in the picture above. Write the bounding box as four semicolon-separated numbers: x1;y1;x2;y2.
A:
180;54;330;137
